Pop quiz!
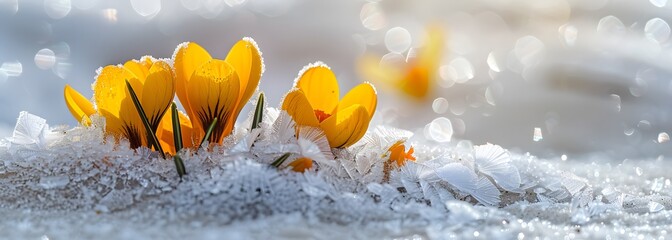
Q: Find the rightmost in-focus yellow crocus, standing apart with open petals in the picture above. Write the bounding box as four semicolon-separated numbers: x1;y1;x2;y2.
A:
282;62;377;148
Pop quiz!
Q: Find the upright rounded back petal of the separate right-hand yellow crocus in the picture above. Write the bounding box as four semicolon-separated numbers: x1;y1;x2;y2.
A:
295;62;340;113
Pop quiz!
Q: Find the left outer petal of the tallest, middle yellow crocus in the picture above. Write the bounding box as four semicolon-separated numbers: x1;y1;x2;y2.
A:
173;42;212;130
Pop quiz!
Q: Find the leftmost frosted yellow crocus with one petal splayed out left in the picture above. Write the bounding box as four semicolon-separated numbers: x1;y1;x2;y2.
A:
64;57;175;148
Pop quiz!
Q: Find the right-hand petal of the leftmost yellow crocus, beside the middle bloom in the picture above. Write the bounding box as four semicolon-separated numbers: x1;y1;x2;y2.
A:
141;61;175;130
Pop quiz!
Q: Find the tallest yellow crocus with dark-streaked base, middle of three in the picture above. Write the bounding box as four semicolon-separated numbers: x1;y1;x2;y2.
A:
173;38;263;143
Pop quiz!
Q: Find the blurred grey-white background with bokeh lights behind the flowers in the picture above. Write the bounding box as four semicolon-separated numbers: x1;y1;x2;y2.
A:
0;0;672;160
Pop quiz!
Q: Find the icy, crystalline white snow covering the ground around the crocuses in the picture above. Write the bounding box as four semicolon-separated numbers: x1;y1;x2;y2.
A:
0;111;672;239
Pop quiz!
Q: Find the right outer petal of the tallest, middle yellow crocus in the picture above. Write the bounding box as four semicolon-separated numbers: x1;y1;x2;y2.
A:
225;38;264;116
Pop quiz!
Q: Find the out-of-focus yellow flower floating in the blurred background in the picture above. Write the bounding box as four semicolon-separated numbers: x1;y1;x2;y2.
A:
358;26;444;99
